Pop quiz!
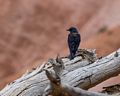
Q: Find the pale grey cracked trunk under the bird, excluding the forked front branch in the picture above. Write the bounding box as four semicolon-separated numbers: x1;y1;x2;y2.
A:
0;49;120;96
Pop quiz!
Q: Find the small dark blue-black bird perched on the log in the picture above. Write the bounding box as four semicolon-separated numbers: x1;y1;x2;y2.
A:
67;27;81;60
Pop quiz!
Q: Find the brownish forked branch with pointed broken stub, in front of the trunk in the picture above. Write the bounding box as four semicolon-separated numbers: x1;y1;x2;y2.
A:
43;65;110;96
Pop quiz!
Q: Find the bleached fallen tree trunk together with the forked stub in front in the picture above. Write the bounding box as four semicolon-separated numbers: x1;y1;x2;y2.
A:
0;49;120;96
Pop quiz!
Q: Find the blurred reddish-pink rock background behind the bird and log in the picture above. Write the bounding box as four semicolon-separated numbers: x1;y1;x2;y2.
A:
0;0;120;90
